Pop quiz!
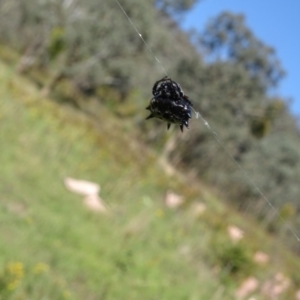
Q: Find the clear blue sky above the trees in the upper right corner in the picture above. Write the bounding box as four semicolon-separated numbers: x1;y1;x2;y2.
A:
182;0;300;117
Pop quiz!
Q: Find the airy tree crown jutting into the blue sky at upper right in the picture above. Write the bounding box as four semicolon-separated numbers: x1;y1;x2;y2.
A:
200;12;284;89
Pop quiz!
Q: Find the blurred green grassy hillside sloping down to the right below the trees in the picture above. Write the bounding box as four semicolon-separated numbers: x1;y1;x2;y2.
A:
0;59;300;300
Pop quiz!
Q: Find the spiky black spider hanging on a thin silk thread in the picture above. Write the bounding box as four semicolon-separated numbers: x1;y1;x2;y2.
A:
146;76;193;131
